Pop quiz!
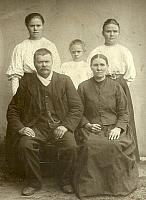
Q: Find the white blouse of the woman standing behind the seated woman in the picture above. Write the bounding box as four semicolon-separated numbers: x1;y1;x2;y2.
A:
87;44;136;83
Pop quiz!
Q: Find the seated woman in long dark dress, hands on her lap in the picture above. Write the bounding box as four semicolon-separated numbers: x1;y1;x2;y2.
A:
73;54;138;198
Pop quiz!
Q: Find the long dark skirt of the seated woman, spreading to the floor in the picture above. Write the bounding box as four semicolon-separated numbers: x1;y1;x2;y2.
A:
73;126;138;199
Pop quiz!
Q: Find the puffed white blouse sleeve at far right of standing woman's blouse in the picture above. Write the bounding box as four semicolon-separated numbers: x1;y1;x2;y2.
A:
124;49;136;84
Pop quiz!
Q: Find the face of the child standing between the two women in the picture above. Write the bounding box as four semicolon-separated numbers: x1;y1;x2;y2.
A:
70;44;84;61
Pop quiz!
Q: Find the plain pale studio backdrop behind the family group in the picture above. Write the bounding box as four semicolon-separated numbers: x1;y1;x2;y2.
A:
0;0;146;156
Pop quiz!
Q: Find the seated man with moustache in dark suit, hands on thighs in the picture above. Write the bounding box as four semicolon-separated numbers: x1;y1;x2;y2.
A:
6;48;83;196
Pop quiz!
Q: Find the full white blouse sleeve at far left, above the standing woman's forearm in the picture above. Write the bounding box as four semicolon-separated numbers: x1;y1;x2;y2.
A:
6;44;24;80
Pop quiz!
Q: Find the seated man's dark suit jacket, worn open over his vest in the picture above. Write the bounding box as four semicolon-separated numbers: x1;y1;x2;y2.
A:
6;72;83;172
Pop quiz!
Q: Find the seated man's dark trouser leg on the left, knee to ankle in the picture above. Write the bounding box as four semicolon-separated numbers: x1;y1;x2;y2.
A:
18;136;42;189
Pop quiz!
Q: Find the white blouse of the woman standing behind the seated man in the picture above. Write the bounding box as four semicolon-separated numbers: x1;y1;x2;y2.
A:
6;37;61;79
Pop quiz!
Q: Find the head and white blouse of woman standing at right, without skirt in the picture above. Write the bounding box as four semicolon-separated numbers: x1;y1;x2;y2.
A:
88;19;136;84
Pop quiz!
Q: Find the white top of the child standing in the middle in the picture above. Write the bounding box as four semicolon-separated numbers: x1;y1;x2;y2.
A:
61;61;92;88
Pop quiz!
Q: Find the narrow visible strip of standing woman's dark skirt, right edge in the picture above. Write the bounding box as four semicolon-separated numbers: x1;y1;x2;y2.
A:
115;77;140;162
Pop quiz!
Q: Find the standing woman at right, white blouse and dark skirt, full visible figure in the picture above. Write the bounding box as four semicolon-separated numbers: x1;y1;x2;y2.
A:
87;19;139;161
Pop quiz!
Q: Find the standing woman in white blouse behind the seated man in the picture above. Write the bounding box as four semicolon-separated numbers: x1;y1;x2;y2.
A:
6;13;61;95
